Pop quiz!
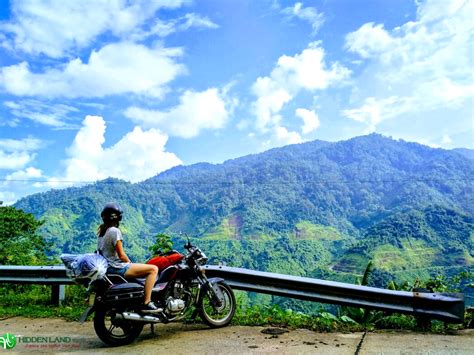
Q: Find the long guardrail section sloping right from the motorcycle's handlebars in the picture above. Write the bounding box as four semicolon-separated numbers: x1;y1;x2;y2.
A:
206;265;465;323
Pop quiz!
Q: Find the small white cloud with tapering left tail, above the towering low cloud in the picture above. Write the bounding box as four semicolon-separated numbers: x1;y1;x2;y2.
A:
125;88;229;138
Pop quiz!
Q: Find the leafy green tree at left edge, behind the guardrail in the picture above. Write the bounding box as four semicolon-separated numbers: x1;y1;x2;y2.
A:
0;203;46;265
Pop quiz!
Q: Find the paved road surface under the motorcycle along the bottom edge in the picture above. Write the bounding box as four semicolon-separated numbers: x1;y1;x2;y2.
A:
0;317;474;355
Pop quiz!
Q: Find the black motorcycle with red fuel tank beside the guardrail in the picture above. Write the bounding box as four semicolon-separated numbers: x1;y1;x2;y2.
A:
63;240;236;346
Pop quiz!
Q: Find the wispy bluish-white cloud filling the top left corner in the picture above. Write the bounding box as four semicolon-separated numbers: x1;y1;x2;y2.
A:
0;0;188;58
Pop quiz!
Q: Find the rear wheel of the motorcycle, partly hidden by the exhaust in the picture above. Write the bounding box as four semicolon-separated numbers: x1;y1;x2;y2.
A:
94;310;143;346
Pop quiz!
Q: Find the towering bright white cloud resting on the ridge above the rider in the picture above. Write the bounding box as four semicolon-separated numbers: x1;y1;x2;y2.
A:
54;116;182;184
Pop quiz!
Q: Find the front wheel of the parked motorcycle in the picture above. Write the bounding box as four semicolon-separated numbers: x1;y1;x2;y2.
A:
199;282;236;328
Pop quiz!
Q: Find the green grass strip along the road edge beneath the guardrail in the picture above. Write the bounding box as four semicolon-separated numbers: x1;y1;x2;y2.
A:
0;285;474;333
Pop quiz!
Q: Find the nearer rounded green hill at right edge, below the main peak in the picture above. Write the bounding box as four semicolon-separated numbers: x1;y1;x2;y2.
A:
333;206;474;280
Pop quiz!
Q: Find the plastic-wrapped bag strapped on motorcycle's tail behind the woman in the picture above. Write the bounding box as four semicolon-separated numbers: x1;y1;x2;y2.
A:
61;253;108;284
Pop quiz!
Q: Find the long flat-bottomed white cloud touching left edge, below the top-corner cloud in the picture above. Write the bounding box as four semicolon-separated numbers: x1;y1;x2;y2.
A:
0;42;185;98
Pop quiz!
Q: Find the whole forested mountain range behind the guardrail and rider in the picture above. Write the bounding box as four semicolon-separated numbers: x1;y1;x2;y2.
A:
12;134;474;292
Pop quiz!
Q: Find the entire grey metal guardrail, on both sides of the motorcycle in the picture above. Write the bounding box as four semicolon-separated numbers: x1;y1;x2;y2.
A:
0;265;465;323
